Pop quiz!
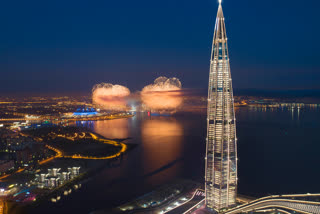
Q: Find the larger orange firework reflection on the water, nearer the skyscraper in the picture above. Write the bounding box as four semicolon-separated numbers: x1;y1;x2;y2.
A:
141;118;183;177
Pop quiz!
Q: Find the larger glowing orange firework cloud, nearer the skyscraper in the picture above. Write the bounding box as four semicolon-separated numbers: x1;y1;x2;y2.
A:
141;77;183;110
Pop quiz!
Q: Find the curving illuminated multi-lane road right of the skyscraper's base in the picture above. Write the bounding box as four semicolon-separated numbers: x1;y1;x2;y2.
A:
225;194;320;214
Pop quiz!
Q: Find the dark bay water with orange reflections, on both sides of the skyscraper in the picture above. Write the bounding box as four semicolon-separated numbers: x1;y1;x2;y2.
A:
23;107;320;213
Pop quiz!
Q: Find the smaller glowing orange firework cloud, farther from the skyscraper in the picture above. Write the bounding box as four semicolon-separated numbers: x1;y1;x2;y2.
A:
92;83;130;110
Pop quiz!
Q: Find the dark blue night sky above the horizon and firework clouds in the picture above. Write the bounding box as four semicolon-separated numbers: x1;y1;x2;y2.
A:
0;0;320;93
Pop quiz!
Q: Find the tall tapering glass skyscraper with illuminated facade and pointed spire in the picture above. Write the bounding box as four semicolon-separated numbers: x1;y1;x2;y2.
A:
205;0;237;211
